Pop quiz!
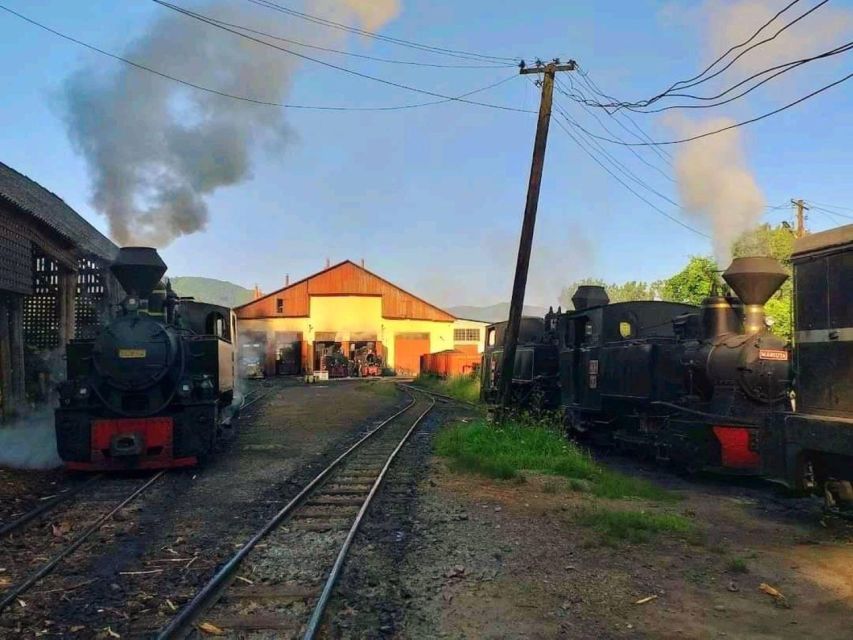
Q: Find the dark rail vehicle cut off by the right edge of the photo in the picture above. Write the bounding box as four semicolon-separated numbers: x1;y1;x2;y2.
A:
761;225;853;500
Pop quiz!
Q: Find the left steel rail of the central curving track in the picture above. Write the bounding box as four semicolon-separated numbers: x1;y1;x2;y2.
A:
157;396;416;640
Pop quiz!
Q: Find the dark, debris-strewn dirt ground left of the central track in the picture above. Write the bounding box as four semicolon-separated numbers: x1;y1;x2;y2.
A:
0;382;404;638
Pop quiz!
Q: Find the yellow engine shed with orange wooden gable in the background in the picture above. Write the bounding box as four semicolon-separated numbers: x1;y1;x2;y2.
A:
234;260;486;376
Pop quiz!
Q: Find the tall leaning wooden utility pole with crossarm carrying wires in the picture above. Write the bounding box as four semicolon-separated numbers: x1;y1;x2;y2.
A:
500;60;577;414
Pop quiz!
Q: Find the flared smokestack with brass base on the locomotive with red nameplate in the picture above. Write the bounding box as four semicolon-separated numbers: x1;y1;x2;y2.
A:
723;256;788;333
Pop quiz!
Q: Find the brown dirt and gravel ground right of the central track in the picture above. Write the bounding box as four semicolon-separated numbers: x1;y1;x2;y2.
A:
396;460;853;640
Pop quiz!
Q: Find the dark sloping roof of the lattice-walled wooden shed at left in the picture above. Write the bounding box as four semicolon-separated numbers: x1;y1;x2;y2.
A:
0;162;118;260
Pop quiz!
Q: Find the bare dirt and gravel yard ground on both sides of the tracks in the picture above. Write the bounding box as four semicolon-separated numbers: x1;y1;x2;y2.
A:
0;381;853;640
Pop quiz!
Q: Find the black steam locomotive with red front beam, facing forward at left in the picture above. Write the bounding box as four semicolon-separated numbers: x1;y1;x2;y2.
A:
55;247;235;470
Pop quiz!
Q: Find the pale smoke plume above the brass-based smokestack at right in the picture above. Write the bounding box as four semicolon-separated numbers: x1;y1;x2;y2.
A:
669;118;765;267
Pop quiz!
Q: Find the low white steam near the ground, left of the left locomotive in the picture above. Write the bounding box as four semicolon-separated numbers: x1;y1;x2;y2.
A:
0;409;62;469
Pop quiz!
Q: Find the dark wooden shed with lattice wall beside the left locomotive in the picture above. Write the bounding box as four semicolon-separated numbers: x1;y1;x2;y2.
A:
0;163;121;420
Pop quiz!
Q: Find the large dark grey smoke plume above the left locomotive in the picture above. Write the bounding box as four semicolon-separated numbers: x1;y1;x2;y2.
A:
63;0;399;247
